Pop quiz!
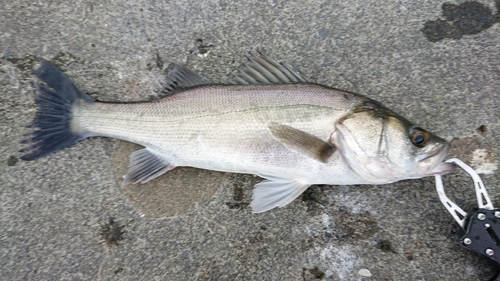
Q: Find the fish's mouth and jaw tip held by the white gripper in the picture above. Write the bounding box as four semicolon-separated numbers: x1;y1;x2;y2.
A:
418;143;457;175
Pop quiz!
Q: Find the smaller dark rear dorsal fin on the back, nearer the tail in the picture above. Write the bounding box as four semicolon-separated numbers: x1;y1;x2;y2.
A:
161;63;210;94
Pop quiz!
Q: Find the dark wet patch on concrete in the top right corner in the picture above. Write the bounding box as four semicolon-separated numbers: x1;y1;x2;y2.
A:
422;0;500;42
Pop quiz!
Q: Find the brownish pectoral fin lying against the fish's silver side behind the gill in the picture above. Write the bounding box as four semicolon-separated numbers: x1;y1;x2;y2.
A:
269;122;337;163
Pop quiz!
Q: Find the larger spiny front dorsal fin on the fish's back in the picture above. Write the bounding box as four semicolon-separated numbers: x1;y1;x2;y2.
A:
231;51;312;85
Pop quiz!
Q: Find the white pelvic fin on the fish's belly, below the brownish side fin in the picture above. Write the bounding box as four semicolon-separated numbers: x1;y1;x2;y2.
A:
250;175;310;213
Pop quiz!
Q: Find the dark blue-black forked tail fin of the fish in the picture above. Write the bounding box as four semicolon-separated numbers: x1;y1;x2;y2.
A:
21;59;94;161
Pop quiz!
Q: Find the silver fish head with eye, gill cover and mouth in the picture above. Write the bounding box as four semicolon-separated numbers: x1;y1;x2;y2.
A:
334;101;455;184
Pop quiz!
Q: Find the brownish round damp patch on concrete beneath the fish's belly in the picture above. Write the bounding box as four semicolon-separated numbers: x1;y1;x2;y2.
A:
113;141;230;218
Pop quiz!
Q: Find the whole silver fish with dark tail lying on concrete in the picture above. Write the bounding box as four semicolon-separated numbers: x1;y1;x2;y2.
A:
21;51;455;213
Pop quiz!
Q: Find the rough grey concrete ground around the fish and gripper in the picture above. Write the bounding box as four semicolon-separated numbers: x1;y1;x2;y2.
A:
0;0;500;280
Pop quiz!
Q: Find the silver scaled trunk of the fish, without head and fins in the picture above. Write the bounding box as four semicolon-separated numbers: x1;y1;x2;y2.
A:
73;84;362;184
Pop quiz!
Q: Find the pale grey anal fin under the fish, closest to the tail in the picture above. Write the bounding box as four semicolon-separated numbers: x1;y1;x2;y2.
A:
122;148;175;186
